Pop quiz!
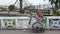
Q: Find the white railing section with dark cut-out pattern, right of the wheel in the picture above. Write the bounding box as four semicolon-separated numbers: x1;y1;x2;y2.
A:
46;16;60;29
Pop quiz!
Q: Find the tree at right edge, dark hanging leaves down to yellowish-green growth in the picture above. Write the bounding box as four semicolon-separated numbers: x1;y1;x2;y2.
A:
49;0;60;16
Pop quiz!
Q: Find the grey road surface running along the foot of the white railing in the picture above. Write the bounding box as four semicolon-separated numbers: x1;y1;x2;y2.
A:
0;30;60;34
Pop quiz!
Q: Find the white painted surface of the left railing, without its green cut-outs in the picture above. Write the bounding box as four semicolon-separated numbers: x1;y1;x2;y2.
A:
0;17;30;29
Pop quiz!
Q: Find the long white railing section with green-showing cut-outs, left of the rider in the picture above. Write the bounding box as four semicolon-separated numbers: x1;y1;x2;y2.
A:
0;16;29;29
